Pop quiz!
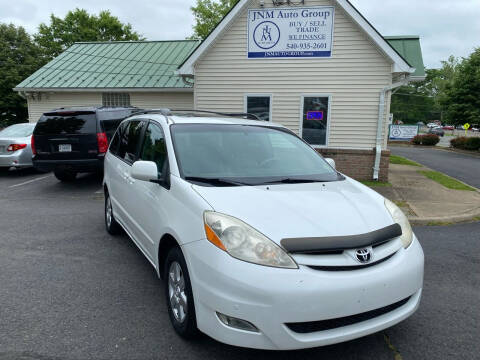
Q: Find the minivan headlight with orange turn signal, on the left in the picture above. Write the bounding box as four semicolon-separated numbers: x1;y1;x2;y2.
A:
203;211;298;269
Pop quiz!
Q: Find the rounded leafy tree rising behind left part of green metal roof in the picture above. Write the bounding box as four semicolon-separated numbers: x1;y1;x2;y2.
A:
34;8;143;60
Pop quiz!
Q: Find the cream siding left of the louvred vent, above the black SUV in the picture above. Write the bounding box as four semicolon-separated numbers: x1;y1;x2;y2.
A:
27;92;102;122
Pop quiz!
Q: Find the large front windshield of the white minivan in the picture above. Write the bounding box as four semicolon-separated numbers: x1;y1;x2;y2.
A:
171;124;343;186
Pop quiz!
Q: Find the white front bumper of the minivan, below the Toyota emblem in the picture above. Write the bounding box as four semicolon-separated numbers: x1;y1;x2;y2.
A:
182;235;424;350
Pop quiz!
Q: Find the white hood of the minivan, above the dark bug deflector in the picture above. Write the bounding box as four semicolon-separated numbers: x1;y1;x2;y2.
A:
193;178;393;244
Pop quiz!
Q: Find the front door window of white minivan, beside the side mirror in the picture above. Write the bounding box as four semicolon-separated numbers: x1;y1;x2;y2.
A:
140;123;168;175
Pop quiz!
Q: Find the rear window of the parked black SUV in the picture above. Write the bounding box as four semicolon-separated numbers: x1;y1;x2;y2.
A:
34;114;97;135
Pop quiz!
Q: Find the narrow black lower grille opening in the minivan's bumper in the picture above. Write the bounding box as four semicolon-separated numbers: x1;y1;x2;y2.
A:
285;296;411;334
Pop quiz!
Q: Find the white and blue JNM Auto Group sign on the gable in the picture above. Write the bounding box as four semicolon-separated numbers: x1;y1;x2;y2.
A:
247;6;334;58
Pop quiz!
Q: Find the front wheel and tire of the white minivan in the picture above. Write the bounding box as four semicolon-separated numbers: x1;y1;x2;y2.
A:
164;247;198;339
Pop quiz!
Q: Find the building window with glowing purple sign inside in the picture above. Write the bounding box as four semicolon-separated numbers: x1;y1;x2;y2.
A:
302;96;330;146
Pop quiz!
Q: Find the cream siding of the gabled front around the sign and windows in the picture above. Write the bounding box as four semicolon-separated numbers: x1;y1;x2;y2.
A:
195;0;392;149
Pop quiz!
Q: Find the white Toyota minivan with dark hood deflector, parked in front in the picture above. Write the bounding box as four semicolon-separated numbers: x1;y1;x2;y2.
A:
104;110;424;349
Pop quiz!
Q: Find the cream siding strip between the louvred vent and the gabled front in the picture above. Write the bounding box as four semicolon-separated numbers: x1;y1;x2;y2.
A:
130;92;193;110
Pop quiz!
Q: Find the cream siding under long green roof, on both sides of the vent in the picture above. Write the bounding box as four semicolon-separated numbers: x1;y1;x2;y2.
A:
27;92;193;122
